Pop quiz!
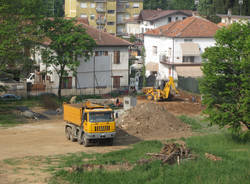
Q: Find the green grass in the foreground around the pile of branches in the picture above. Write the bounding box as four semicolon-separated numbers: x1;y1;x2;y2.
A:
50;133;250;184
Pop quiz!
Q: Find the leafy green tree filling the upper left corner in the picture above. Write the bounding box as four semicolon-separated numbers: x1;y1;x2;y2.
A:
0;0;45;76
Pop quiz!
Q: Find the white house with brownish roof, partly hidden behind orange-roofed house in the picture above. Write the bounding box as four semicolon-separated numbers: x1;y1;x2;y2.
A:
126;9;193;34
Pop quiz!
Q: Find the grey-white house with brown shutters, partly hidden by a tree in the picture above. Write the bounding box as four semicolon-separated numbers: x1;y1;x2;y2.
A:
35;21;130;95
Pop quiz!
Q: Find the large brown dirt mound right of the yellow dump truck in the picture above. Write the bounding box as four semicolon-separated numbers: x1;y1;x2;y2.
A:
117;102;191;139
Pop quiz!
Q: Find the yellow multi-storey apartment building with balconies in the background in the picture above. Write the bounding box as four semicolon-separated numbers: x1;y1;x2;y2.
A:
65;0;143;35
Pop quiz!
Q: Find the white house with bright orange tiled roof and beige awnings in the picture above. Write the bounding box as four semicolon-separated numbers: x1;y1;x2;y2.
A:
144;16;219;80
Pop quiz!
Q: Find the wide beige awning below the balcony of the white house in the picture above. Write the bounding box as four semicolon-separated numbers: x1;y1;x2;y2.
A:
176;66;203;77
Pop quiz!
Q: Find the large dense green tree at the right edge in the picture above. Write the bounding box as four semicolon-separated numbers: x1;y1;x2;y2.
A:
200;23;250;138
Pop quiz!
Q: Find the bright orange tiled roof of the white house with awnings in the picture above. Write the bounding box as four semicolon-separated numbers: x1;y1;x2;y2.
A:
145;16;220;38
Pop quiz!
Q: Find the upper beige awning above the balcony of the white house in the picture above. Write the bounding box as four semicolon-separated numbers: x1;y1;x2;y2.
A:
181;42;200;56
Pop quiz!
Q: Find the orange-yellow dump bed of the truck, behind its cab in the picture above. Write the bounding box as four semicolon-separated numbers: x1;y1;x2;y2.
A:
63;104;84;126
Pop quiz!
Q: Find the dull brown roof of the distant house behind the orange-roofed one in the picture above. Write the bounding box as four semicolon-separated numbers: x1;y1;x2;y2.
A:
139;10;192;21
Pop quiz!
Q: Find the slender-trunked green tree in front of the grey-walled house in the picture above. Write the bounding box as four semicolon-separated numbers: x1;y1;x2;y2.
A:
41;17;96;98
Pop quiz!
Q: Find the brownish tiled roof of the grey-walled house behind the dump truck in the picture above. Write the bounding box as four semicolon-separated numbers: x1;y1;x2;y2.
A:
80;22;131;46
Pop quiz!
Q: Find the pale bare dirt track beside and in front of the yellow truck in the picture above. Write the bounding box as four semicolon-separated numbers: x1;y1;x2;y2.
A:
0;119;133;160
